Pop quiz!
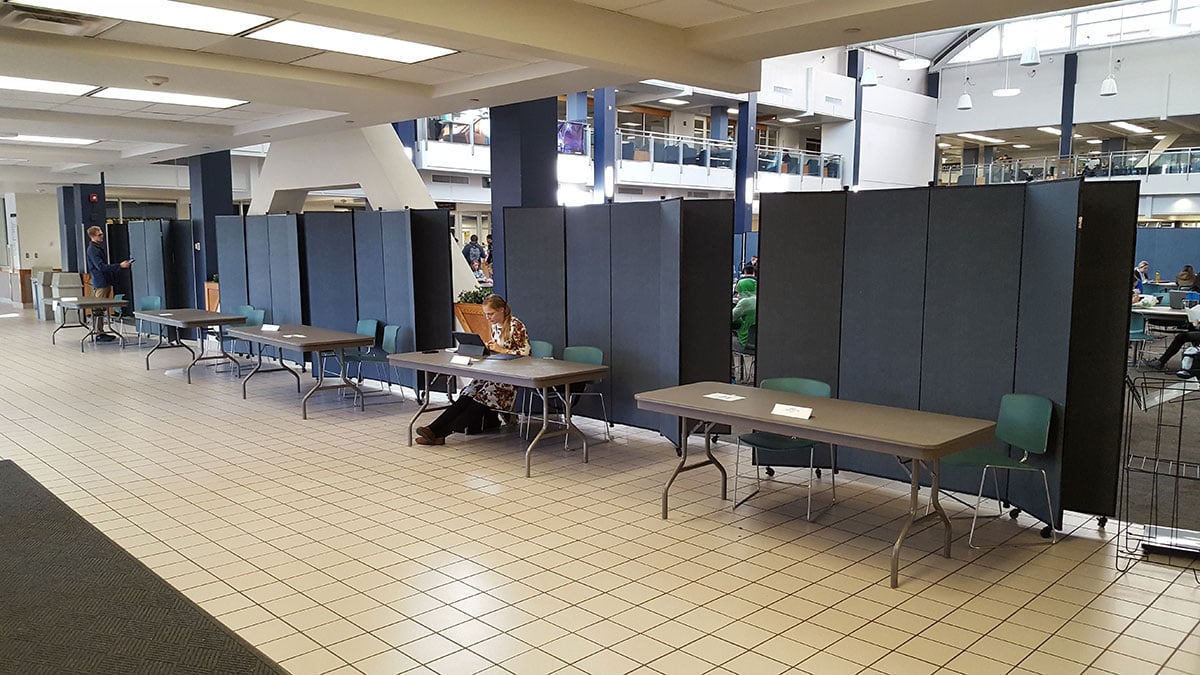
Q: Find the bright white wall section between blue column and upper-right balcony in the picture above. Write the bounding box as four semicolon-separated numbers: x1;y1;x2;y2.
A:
858;85;937;187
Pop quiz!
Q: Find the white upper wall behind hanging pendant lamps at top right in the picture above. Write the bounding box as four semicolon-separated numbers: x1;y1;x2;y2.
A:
937;36;1200;133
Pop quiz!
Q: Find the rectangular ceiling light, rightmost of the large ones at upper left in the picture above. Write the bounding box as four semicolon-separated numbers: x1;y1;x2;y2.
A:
246;22;455;64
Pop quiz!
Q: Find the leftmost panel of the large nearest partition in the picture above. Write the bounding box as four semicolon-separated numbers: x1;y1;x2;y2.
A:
756;192;847;389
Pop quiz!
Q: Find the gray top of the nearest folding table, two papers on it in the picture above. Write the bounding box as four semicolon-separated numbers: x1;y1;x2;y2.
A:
634;382;996;460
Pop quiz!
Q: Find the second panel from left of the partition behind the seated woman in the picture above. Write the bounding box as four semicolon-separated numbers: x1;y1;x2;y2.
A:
566;204;619;419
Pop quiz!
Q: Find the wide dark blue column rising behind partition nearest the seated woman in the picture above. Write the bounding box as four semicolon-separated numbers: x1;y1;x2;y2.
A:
491;98;558;295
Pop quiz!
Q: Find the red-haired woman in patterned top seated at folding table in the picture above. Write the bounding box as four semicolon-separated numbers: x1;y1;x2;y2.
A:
416;295;529;446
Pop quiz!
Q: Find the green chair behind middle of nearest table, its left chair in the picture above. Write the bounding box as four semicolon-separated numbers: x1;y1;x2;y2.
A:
733;377;838;520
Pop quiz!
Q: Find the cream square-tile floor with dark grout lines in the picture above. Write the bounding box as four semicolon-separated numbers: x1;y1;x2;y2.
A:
0;311;1200;675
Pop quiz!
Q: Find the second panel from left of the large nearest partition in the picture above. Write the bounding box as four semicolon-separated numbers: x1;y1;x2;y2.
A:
838;187;929;479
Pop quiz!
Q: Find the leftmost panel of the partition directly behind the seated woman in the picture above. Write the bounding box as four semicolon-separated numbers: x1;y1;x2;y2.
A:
504;207;566;351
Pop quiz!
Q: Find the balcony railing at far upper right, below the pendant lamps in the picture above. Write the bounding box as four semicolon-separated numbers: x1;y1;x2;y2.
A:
940;148;1200;185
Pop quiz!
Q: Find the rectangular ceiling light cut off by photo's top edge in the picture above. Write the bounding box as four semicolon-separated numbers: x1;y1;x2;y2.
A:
20;0;275;35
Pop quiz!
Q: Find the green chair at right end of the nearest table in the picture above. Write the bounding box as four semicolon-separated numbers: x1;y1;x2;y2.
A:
942;394;1058;549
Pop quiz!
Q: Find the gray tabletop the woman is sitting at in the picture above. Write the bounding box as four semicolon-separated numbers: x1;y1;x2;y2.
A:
388;350;608;388
